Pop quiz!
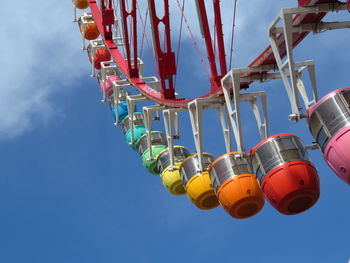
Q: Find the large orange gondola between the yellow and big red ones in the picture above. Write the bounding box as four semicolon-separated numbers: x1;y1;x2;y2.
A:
209;152;264;219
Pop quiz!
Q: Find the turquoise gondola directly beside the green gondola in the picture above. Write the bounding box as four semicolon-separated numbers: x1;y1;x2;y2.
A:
120;112;146;151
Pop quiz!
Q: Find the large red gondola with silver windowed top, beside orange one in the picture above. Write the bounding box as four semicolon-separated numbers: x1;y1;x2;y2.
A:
250;134;320;215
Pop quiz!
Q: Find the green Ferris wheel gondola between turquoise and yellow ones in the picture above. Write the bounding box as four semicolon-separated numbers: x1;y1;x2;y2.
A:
137;131;168;174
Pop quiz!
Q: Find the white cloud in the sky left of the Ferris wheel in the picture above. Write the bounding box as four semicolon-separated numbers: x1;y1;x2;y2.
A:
0;0;88;139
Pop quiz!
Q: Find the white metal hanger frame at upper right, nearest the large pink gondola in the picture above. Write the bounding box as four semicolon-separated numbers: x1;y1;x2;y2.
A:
268;2;350;121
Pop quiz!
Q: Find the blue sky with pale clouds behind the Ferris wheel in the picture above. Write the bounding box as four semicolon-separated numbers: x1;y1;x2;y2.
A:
0;0;350;263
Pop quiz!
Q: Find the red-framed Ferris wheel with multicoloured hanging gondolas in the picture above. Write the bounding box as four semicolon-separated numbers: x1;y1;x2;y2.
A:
73;0;350;219
